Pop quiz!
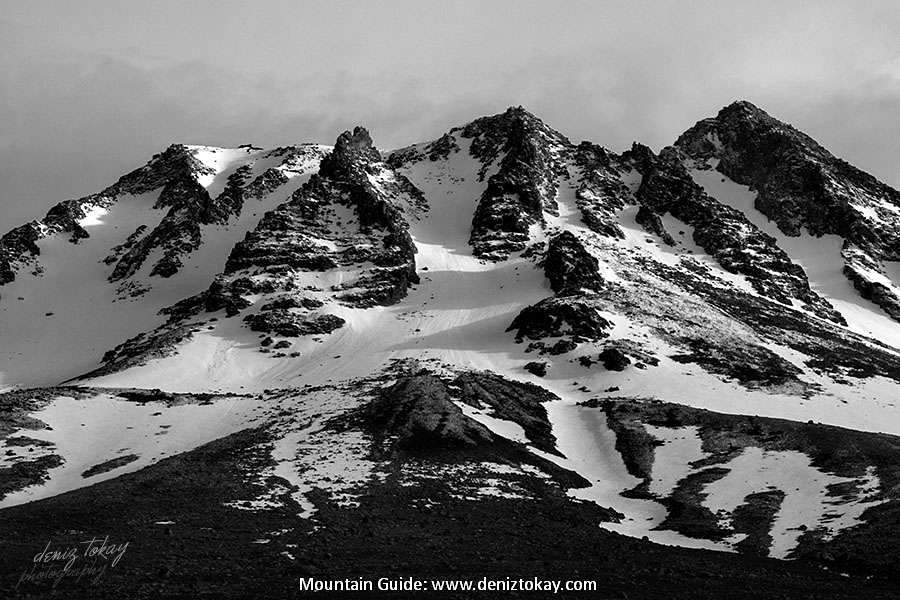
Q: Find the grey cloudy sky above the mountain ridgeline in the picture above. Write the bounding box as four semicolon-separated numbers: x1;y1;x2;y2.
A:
0;0;900;225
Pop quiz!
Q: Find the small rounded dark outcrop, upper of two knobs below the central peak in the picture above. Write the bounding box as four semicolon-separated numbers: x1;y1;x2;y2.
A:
544;231;603;296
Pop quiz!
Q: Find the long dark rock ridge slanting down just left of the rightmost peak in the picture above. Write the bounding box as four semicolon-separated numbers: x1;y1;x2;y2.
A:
630;148;844;323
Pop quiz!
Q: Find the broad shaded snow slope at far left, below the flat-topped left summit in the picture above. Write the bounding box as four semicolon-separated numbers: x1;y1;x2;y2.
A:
0;150;317;390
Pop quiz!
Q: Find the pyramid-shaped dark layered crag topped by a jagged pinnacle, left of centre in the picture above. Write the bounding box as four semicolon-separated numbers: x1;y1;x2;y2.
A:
225;127;422;306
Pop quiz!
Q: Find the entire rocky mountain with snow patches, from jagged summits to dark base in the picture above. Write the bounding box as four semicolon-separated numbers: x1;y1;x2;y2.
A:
0;101;900;598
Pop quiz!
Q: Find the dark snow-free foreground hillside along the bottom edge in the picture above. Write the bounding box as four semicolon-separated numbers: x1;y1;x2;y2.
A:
0;430;898;600
